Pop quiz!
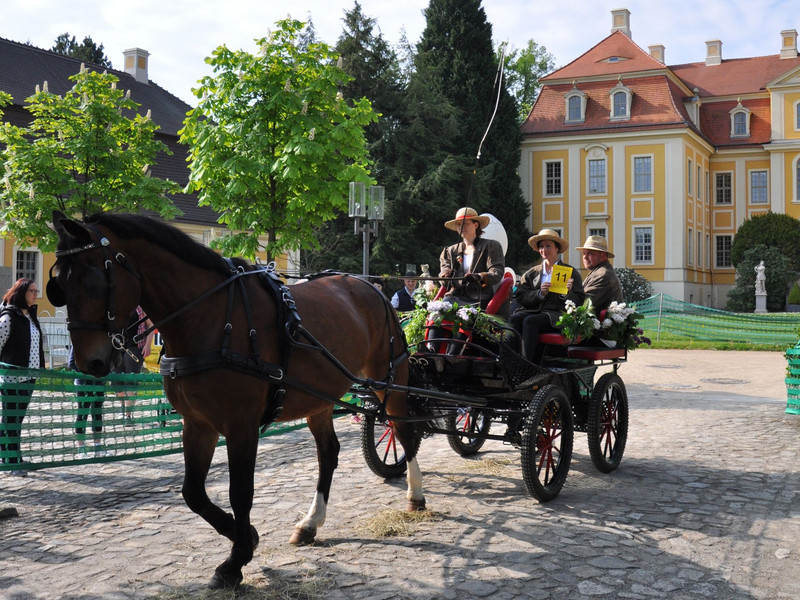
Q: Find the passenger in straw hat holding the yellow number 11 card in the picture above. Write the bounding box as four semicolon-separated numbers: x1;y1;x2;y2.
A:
510;229;584;362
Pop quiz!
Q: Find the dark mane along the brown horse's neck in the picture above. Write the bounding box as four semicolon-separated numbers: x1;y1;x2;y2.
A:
86;213;239;273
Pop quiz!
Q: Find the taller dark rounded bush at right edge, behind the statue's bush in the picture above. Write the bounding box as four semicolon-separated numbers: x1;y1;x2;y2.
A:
731;212;800;272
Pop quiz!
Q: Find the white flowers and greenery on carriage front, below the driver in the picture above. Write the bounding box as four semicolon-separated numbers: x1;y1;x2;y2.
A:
403;290;510;346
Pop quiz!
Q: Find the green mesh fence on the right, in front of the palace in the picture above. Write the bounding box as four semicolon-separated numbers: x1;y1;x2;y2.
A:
636;294;800;347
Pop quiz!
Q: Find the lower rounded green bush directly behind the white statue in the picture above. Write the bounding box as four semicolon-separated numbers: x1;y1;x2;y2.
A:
727;244;797;312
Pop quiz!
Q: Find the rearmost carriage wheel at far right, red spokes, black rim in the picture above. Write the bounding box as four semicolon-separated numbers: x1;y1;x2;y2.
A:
586;373;628;473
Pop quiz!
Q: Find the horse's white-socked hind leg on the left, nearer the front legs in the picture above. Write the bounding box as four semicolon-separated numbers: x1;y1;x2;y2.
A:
289;409;339;546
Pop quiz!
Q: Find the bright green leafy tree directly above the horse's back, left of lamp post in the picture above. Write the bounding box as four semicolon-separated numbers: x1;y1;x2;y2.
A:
181;19;377;259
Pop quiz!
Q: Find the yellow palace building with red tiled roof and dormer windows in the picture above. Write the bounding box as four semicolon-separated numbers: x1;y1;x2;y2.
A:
520;9;800;308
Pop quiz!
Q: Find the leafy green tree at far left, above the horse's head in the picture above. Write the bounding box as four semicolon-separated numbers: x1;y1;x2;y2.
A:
0;68;179;251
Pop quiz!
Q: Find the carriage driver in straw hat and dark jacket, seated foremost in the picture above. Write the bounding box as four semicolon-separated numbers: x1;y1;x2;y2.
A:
439;206;506;308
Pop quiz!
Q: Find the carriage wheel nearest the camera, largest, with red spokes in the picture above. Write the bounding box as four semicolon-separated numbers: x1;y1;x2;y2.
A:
522;385;574;502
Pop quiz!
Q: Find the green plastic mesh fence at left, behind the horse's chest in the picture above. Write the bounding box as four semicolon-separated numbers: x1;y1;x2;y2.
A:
0;363;350;471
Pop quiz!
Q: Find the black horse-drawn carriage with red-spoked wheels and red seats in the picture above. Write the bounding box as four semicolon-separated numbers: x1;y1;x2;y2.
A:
358;279;628;502
